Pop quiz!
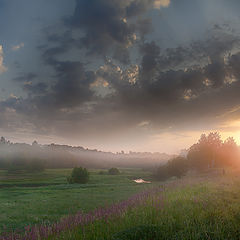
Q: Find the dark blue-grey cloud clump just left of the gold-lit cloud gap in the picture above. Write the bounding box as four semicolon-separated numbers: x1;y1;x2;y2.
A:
24;61;95;117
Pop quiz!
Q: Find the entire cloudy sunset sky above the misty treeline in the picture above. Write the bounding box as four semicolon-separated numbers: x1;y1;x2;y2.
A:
0;0;240;153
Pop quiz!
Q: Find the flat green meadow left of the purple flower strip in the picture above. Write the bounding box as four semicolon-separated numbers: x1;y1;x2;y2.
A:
0;169;153;232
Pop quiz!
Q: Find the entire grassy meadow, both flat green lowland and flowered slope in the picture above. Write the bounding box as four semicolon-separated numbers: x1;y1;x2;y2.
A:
0;169;240;240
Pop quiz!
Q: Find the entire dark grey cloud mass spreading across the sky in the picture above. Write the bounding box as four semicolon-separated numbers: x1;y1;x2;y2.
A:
3;0;240;144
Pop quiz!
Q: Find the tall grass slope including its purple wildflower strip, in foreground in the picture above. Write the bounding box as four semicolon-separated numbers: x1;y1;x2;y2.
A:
3;174;240;240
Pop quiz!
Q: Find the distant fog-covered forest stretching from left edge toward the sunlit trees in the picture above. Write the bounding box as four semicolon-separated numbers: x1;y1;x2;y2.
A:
0;137;173;172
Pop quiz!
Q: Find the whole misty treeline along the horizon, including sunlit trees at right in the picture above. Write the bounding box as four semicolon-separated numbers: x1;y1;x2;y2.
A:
0;132;240;174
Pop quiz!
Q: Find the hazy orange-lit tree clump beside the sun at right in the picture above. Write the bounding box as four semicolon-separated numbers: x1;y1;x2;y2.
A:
155;132;240;180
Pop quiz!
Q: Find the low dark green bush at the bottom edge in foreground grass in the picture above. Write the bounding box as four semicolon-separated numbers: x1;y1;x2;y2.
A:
112;226;161;240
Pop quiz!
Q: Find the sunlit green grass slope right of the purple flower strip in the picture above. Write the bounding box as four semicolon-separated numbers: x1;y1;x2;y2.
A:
47;172;240;240
